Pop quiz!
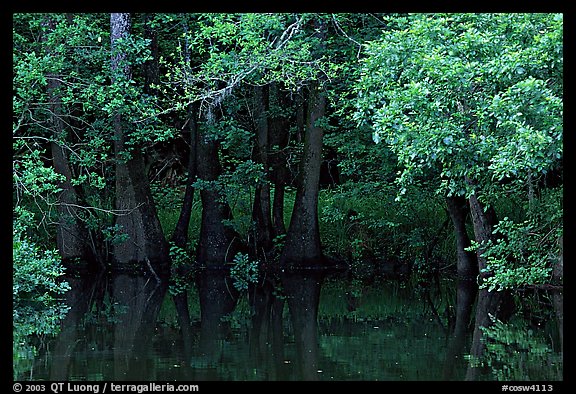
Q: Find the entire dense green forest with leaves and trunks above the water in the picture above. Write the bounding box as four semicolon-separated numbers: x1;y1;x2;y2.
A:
13;13;564;370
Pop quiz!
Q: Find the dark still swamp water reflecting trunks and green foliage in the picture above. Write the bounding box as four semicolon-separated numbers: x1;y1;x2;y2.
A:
14;272;563;382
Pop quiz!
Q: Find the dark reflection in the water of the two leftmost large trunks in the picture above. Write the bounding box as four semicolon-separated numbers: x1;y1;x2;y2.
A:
49;273;166;381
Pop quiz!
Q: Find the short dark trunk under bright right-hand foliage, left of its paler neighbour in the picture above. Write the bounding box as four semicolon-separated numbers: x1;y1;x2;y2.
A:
446;196;478;280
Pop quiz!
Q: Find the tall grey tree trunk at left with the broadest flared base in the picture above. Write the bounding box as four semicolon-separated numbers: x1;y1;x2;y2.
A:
110;13;169;271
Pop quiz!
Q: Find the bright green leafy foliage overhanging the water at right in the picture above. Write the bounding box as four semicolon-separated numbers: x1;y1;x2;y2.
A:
355;14;563;289
